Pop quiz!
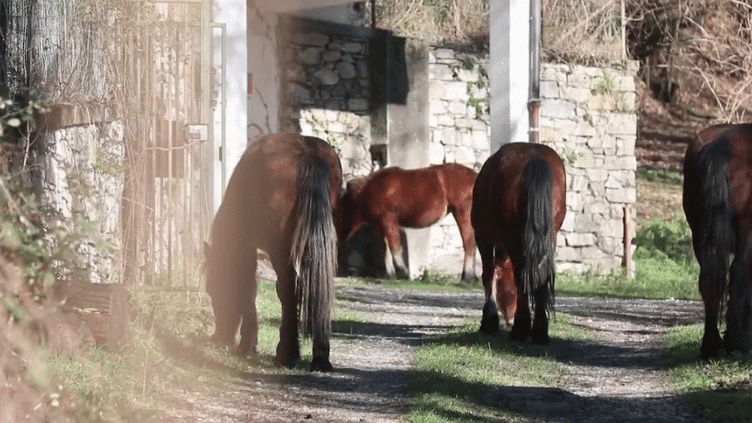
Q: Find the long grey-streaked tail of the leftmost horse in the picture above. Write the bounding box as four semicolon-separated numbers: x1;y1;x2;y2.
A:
290;155;339;342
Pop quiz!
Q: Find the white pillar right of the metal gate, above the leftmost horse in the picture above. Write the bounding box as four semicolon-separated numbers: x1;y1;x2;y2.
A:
212;0;248;209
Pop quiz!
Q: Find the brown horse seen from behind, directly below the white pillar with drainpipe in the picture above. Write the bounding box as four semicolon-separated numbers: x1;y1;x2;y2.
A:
472;143;566;344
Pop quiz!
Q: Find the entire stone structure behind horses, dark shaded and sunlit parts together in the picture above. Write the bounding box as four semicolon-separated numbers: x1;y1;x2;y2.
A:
280;15;636;276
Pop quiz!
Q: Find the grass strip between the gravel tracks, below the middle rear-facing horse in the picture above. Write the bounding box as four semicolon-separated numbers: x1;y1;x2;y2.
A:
407;313;584;423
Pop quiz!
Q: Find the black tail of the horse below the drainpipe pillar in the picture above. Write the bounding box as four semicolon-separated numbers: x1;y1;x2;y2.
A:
520;157;556;312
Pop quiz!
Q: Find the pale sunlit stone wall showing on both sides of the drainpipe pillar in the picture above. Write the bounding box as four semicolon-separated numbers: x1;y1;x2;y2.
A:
429;58;637;273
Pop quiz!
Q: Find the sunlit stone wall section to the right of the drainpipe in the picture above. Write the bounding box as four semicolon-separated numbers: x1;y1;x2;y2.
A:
540;62;637;273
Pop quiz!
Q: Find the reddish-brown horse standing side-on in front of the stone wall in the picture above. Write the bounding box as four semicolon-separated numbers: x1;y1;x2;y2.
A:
339;163;476;281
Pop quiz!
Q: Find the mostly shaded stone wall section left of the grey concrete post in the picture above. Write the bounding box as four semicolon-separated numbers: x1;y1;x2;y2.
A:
279;19;375;177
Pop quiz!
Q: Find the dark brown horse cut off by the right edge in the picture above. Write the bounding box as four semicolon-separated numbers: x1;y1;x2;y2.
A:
682;124;752;359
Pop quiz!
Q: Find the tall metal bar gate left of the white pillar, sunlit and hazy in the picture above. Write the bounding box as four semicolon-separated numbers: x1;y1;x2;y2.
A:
123;0;224;289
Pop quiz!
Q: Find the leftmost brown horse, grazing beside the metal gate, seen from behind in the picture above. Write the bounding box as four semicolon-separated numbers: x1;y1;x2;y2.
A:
205;134;342;371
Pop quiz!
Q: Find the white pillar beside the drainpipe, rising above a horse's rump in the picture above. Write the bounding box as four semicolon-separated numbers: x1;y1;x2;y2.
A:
491;0;530;153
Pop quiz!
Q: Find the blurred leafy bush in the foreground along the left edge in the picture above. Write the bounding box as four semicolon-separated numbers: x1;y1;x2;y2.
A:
0;95;76;422
